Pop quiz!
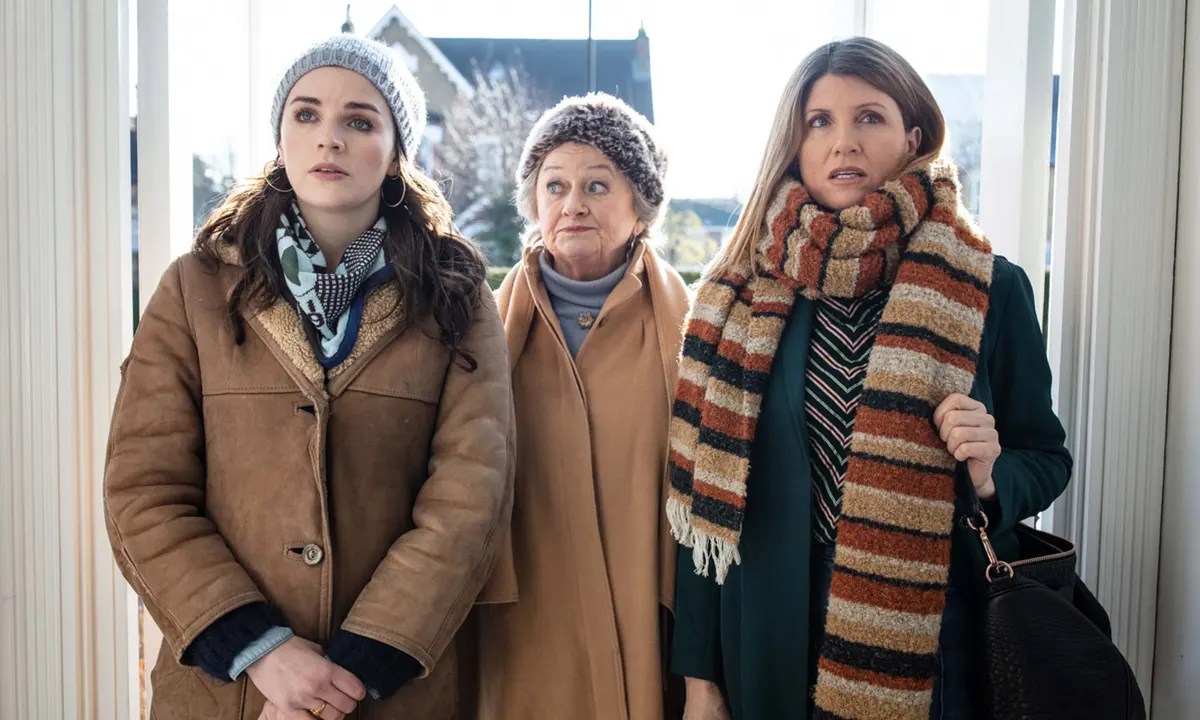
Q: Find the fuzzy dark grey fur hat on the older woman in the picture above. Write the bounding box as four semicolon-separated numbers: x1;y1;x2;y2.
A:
517;92;667;211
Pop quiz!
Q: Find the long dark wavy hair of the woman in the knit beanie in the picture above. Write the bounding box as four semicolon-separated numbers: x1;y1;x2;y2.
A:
192;154;487;371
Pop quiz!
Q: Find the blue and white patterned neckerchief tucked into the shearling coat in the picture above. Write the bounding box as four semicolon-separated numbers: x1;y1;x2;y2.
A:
275;203;388;367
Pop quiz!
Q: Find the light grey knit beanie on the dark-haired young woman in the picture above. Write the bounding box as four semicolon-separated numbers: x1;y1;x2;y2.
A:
271;35;425;160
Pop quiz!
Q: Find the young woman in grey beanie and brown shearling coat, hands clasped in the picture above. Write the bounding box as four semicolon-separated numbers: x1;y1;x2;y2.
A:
104;35;514;720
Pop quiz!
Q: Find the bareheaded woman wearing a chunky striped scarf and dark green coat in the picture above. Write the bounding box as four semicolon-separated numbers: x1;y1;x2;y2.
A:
667;37;1072;720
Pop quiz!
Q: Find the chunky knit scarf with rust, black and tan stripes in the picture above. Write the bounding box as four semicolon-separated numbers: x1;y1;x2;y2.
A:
667;160;992;720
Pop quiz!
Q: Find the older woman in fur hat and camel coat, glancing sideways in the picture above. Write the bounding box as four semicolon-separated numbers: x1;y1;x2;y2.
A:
476;95;688;720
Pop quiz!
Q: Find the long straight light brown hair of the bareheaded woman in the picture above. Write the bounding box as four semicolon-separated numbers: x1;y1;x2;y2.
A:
704;37;946;277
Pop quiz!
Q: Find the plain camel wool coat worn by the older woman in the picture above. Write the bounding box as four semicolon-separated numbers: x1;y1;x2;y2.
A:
476;242;689;720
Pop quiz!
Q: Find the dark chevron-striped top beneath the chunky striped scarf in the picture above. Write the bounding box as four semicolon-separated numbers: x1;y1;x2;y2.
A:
804;288;888;545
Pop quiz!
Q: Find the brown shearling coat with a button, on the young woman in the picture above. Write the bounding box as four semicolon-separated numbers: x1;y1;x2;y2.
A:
104;243;515;720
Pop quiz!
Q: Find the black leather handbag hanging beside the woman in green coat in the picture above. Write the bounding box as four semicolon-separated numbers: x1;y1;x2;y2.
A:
959;480;1146;720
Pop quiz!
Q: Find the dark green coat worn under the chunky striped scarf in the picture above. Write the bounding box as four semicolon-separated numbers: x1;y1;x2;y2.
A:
671;256;1072;720
